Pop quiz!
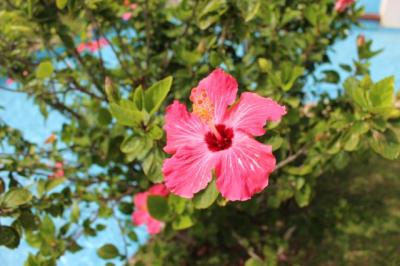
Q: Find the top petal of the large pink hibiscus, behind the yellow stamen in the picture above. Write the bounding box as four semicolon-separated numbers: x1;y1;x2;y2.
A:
198;68;238;124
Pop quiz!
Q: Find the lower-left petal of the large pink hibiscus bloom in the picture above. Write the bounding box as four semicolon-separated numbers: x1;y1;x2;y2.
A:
162;142;216;198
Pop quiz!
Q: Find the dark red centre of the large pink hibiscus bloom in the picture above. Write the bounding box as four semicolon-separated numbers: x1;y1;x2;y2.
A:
205;124;233;152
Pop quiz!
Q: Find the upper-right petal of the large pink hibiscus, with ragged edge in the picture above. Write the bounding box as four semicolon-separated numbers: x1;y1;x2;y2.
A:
225;92;286;136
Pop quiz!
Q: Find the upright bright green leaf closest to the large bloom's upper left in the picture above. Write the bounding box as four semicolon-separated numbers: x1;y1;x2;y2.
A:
144;76;172;115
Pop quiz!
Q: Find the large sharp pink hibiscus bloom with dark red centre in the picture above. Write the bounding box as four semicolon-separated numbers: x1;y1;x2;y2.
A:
162;69;286;201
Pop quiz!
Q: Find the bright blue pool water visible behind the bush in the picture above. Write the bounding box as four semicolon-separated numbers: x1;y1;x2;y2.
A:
0;0;400;266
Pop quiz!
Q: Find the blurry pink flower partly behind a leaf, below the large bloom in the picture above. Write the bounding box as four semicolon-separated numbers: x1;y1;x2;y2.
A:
132;184;169;235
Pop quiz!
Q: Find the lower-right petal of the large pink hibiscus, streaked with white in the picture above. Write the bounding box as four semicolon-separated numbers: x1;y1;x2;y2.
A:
215;133;275;201
